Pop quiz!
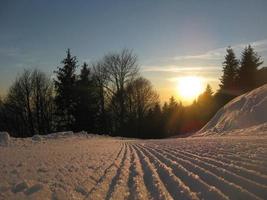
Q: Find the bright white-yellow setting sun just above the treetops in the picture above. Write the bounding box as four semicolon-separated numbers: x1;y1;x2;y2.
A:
177;76;203;101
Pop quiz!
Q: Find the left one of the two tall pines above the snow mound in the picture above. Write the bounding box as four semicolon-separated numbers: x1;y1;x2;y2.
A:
220;47;239;95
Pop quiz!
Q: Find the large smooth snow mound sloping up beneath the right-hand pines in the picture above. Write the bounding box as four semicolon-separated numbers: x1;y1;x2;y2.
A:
196;84;267;135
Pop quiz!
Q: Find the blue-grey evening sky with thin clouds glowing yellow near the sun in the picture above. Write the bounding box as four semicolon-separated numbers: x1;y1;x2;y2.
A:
0;0;267;101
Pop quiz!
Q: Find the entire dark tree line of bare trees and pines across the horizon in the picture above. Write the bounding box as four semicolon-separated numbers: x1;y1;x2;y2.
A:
0;45;267;138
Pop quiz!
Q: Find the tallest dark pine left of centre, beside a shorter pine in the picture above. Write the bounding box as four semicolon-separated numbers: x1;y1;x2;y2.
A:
54;49;77;130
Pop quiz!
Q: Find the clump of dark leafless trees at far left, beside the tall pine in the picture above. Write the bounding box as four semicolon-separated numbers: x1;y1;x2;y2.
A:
1;70;53;137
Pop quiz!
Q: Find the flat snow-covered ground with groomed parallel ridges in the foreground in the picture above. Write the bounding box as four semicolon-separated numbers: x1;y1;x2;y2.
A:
0;132;267;200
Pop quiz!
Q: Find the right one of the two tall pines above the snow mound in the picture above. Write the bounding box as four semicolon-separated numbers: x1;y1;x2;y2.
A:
238;45;263;92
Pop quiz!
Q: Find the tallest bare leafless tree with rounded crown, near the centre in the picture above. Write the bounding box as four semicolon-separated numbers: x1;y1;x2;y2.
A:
103;49;138;132
